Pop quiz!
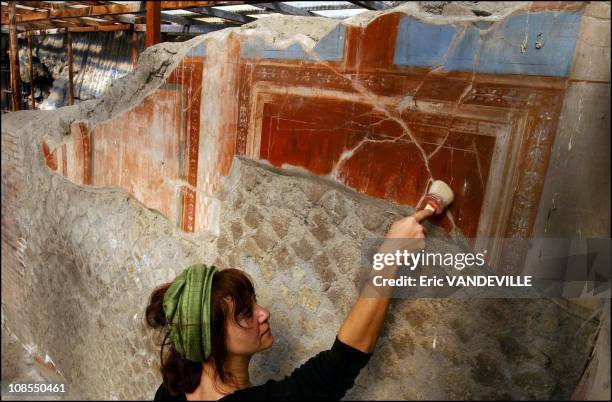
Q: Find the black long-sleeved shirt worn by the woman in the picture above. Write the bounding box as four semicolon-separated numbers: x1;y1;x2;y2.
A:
154;337;372;401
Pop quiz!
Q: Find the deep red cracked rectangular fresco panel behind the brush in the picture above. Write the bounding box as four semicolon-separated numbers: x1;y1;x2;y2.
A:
259;95;495;236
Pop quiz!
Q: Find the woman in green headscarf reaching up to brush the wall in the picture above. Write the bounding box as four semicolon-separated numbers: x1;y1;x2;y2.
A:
146;210;431;401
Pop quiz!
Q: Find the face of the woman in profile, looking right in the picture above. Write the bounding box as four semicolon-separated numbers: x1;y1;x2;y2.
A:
226;296;274;355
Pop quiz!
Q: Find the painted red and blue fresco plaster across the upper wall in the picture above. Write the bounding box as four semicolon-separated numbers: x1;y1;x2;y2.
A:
39;2;584;270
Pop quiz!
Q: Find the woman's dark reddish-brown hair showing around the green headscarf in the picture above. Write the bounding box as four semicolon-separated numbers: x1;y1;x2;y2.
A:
145;268;255;395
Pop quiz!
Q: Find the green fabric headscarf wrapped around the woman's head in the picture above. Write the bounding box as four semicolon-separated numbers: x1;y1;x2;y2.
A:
164;264;217;362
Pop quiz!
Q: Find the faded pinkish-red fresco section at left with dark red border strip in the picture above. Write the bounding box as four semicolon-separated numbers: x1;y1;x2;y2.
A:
83;60;203;231
